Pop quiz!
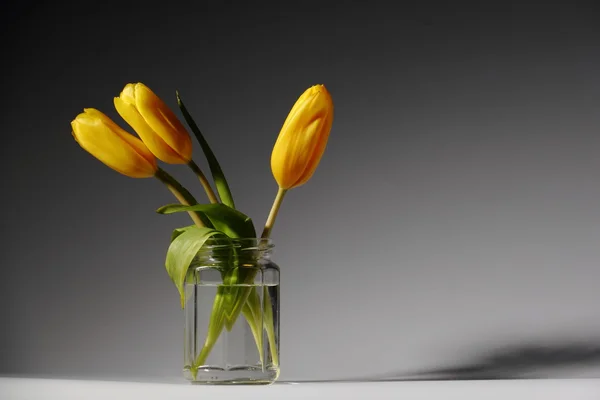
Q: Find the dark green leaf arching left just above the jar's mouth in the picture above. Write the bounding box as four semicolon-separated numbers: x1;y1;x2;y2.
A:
156;203;256;238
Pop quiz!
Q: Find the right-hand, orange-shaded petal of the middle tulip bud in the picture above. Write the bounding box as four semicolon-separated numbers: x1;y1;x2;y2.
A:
135;83;192;162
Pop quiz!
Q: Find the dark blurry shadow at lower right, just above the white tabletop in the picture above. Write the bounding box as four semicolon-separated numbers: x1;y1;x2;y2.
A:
284;342;600;382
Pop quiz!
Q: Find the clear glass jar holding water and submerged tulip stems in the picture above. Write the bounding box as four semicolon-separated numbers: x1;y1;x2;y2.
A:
183;238;279;384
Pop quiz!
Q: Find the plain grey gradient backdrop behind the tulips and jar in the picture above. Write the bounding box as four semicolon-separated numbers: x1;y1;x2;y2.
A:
0;1;600;380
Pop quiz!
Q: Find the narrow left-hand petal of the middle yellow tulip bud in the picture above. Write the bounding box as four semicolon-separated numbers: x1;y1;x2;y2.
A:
114;97;186;164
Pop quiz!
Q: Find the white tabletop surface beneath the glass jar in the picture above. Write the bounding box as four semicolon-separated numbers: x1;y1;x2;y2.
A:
0;378;600;400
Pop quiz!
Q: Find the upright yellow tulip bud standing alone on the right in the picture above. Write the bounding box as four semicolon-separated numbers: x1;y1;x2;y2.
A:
271;85;333;190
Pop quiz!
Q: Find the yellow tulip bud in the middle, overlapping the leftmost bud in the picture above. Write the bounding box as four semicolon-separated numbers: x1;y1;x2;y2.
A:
114;83;192;164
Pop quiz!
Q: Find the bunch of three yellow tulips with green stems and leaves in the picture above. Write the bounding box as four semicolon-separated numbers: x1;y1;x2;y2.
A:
71;83;333;376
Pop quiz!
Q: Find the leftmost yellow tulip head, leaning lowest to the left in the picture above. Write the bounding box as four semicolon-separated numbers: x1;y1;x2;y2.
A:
71;108;158;178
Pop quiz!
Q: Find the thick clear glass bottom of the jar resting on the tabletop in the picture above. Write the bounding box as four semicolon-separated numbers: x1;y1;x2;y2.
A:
183;365;279;385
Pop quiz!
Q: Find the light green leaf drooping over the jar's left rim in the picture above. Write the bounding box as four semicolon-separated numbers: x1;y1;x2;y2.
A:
165;226;222;308
